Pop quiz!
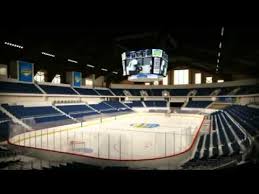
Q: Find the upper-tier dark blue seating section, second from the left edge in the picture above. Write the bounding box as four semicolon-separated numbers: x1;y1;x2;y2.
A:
39;85;77;95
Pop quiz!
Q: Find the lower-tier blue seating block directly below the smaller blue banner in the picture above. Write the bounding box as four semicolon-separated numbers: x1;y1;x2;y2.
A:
57;104;98;121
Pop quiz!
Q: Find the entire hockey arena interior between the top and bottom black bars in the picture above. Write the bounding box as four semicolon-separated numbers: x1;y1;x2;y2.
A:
0;25;259;171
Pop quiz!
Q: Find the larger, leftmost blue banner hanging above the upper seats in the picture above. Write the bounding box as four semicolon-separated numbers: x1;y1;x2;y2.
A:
17;61;34;82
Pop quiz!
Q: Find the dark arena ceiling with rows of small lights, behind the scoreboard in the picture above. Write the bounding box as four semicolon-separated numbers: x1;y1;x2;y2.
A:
0;24;259;80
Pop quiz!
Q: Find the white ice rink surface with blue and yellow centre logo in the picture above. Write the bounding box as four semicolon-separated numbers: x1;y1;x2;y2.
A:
11;113;203;160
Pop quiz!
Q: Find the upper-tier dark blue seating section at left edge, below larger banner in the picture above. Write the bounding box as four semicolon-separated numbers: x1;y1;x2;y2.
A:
0;81;42;94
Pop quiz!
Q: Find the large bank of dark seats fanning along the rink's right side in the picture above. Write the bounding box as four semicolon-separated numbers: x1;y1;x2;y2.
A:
183;105;255;168
